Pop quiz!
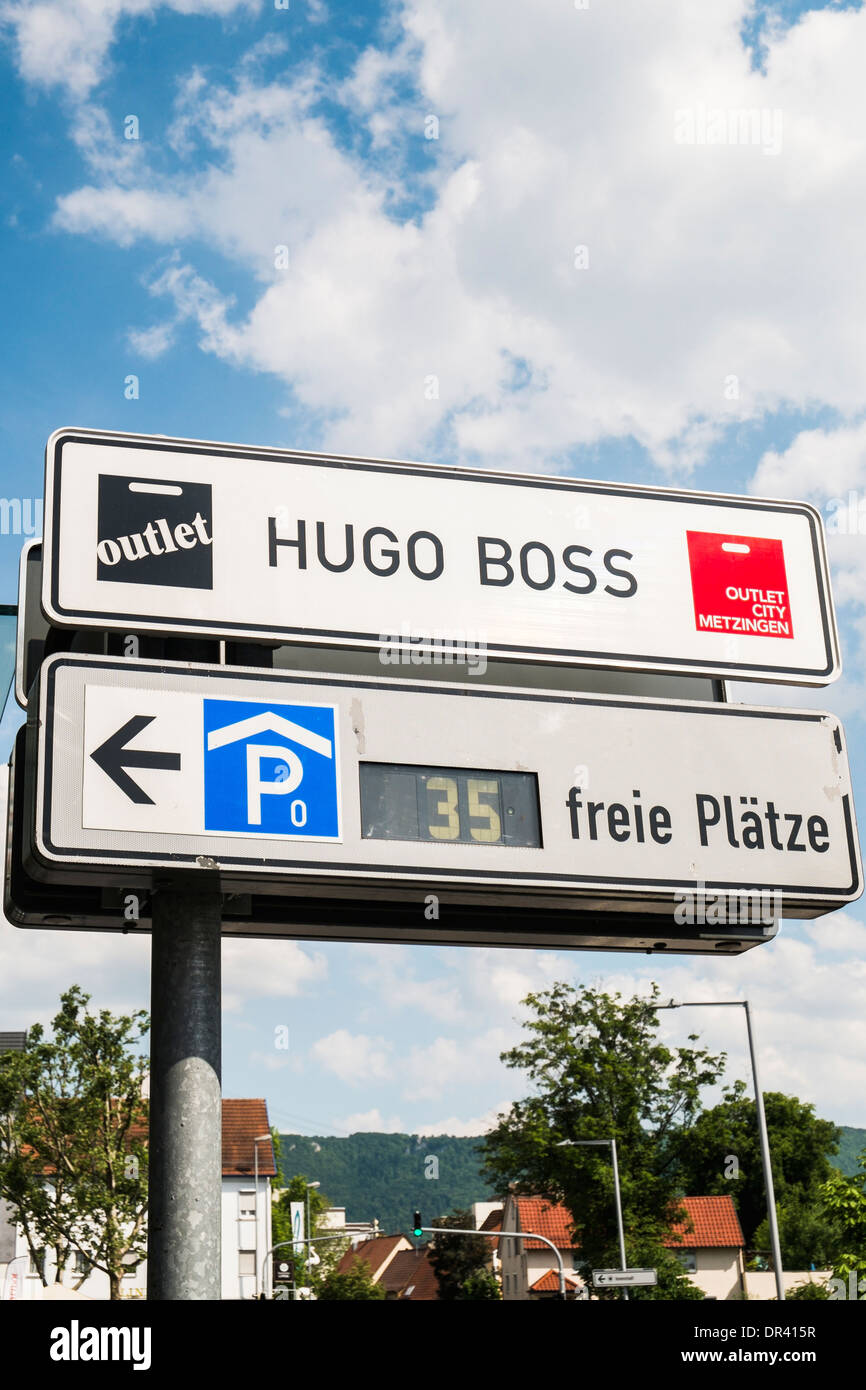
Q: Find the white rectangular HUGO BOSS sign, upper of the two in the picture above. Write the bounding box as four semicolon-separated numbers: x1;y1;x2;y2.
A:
42;430;840;685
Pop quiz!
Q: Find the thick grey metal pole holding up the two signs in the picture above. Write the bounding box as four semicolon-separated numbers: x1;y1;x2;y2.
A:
147;892;222;1301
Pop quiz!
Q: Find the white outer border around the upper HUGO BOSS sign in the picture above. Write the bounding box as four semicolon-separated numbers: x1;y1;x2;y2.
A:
42;428;841;685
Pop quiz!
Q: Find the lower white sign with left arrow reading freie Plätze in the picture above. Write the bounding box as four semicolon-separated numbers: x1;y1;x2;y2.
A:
26;653;860;926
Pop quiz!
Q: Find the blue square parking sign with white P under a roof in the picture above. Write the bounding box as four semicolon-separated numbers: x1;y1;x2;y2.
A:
203;699;341;840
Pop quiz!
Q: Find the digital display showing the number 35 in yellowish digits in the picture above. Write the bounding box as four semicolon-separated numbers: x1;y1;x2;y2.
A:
361;763;541;849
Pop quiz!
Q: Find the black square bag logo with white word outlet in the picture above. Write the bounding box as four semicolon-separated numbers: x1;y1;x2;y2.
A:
96;474;214;589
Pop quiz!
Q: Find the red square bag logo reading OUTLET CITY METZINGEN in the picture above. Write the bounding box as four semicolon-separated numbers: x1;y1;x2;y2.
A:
685;531;794;637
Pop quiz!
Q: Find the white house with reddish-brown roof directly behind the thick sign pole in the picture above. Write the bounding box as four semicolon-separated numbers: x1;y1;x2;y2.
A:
0;1099;277;1298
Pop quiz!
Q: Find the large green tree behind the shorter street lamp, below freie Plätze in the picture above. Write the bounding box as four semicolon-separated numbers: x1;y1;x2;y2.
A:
482;984;724;1280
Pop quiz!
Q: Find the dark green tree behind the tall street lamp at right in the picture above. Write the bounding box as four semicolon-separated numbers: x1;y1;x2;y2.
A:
677;1081;841;1269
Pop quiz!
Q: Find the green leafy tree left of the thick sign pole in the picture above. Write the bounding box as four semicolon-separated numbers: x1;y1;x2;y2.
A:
0;986;149;1298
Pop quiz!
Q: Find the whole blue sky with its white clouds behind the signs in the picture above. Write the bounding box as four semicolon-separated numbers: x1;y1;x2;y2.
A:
0;0;866;1173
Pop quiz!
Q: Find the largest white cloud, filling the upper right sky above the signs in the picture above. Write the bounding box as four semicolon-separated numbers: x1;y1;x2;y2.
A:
25;0;866;468
